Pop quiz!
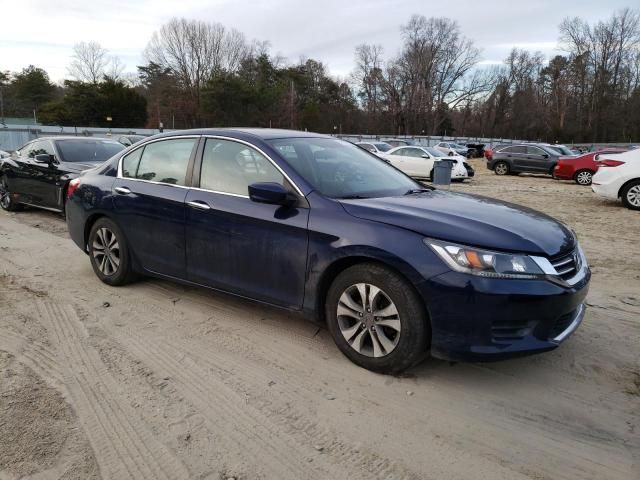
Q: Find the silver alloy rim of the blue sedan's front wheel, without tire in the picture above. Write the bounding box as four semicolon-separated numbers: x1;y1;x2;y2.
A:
337;283;401;358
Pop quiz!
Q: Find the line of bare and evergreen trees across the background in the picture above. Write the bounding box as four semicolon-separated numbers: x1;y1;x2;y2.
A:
0;9;640;142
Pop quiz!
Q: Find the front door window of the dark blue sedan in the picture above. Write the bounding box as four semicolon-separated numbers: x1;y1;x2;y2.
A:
200;138;282;196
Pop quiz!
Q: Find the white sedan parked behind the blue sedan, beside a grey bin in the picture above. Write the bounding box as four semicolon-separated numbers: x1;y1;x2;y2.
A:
380;146;473;180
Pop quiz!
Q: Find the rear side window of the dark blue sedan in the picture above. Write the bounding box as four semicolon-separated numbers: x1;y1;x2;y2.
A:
122;138;197;186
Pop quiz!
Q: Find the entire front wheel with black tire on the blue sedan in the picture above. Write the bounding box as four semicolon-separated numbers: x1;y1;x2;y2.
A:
325;263;431;374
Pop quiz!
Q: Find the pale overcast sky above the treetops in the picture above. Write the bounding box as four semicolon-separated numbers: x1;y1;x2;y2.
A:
0;0;635;81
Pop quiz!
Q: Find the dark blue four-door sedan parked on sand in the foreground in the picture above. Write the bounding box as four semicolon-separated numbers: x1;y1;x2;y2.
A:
66;129;591;373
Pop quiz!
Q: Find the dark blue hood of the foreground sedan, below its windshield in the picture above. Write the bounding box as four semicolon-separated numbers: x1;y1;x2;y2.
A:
341;190;576;257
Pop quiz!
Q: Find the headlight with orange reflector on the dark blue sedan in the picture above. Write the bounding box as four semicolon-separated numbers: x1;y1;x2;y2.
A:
424;238;545;279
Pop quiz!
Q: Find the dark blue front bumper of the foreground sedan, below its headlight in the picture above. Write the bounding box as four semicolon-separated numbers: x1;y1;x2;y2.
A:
421;266;591;361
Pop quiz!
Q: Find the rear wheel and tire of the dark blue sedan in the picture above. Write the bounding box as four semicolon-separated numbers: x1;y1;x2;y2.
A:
88;217;135;287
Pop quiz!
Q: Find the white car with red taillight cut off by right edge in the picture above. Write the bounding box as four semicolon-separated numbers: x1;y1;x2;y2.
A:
591;149;640;210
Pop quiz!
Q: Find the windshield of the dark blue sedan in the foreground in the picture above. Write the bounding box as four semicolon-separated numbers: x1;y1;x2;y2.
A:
268;138;422;198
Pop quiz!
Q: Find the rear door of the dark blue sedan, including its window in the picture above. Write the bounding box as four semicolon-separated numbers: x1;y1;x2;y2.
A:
113;136;199;279
